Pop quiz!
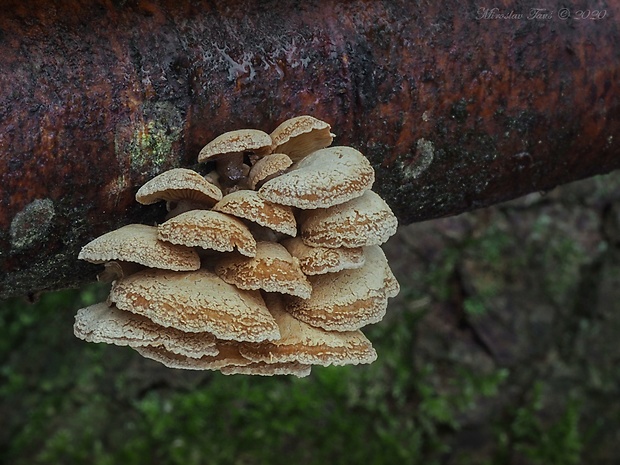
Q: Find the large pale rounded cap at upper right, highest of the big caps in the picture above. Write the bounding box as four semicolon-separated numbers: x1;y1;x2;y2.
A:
258;147;375;209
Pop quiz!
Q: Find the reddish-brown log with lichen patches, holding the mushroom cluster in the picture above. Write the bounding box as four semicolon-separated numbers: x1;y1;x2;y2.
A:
0;0;620;297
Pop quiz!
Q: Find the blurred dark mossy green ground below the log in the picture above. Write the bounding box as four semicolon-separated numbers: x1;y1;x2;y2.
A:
0;173;620;465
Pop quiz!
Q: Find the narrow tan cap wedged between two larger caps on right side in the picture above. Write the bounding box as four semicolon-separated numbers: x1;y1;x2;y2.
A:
282;237;364;275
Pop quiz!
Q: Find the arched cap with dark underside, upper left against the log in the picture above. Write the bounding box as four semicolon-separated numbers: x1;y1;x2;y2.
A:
136;168;222;206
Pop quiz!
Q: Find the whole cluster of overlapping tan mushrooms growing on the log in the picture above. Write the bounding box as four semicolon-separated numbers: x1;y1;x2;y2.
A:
74;116;399;376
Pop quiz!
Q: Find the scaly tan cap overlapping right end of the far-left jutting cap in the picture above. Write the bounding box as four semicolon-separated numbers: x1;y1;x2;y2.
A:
157;210;256;257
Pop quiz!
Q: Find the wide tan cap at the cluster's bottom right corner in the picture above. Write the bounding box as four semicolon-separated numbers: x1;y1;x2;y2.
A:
239;295;377;366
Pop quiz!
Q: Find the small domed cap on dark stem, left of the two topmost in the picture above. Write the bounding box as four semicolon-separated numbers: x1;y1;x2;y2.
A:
198;129;272;163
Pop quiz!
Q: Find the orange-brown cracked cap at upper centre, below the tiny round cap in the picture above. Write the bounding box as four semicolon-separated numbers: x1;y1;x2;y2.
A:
213;190;297;236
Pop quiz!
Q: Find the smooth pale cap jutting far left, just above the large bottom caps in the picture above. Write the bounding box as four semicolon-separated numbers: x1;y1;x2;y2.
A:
78;224;200;271
